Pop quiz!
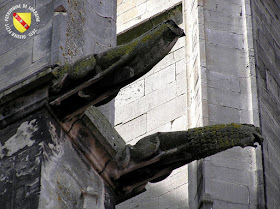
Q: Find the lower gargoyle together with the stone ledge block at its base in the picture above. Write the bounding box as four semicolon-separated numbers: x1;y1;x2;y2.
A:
59;108;263;202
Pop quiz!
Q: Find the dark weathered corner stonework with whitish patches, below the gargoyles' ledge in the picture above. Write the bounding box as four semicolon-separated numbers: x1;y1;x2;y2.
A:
0;111;114;209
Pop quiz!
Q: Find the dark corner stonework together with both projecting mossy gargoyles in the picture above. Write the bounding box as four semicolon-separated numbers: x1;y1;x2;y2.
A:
0;20;262;209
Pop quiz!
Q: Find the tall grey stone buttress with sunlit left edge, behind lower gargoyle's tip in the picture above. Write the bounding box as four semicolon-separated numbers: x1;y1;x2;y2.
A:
184;0;262;208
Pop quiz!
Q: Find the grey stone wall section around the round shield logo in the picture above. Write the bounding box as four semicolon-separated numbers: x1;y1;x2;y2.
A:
0;0;54;90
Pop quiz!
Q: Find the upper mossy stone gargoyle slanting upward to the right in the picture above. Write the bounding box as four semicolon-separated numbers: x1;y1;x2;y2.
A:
50;20;184;120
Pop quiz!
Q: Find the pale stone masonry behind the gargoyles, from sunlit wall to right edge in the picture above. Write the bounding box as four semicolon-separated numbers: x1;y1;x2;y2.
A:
115;0;280;209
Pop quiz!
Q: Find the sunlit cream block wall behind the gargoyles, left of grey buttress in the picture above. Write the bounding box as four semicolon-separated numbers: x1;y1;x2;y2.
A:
115;1;188;209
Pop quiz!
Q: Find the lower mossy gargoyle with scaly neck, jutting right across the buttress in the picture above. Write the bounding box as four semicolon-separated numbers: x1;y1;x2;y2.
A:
114;124;263;198
